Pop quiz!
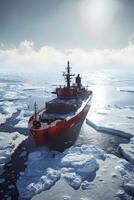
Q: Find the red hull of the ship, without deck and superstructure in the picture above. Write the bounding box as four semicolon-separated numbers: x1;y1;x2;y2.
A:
29;96;92;146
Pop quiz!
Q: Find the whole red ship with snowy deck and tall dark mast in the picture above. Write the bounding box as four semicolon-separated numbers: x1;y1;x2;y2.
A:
28;61;93;149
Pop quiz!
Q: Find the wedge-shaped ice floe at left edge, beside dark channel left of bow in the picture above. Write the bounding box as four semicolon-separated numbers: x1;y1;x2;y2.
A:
0;132;27;174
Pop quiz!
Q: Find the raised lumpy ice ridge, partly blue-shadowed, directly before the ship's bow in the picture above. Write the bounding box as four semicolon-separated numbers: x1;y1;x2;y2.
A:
17;145;105;198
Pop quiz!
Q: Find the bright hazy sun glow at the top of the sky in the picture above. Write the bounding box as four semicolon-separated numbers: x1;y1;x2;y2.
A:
80;0;112;32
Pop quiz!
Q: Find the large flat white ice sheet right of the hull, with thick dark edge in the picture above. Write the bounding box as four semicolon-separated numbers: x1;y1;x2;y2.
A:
86;107;134;138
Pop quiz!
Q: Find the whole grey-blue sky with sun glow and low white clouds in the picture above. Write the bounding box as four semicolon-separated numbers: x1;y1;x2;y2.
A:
0;0;134;72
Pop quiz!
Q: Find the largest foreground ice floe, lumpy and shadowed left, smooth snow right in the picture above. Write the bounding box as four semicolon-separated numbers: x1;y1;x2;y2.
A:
28;145;134;200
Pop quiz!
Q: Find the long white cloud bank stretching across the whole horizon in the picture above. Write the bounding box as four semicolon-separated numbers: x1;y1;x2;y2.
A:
0;40;134;71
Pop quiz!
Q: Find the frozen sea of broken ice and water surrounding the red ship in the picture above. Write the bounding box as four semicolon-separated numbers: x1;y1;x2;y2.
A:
0;70;134;200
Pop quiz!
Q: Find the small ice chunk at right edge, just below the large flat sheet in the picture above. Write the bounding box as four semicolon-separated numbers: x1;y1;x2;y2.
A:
119;137;134;164
